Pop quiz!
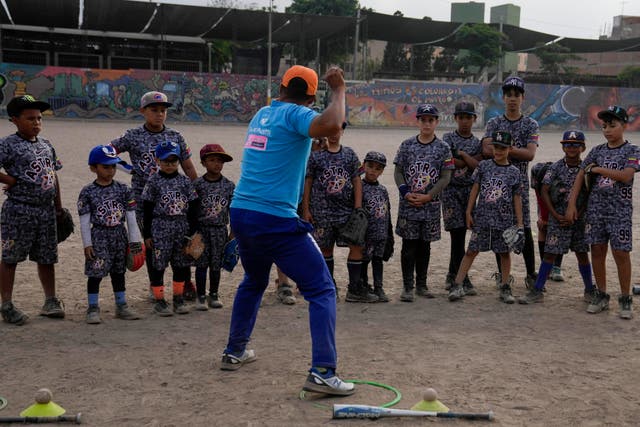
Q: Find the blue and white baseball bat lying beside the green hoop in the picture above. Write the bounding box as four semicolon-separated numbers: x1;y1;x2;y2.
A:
333;405;493;421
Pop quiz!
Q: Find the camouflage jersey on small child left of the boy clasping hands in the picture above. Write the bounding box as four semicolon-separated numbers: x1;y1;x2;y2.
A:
362;179;391;242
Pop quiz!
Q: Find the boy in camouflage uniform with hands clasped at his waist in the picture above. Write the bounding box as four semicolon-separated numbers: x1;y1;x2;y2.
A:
393;104;455;302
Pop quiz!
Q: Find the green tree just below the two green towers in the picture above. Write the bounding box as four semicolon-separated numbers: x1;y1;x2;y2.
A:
455;24;507;69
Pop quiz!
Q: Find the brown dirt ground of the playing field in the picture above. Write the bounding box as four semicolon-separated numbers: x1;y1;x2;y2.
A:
0;119;640;426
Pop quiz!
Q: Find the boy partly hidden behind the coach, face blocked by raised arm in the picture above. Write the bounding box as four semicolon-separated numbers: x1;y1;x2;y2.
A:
302;123;378;302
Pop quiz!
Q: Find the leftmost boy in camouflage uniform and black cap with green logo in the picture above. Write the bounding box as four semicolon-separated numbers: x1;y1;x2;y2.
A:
0;95;64;325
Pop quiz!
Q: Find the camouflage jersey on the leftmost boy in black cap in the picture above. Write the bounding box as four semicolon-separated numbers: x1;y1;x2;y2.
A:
0;134;62;205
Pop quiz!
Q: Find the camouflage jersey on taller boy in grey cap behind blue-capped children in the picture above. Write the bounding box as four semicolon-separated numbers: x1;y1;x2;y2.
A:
111;125;191;196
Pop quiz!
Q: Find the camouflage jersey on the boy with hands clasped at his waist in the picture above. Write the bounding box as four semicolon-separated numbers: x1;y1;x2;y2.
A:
393;136;455;222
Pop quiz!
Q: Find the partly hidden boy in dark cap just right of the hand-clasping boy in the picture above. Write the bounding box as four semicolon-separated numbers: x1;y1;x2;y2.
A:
442;102;482;295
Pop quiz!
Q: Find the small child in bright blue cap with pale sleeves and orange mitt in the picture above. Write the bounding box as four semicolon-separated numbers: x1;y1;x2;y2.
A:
78;145;142;324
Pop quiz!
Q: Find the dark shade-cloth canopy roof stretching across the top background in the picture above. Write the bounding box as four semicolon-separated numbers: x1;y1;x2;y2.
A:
0;0;640;53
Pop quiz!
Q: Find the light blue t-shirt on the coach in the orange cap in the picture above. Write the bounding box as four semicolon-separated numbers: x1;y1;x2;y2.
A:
231;101;318;218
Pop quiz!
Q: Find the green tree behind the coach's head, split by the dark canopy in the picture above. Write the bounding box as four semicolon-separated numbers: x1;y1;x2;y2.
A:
285;0;360;64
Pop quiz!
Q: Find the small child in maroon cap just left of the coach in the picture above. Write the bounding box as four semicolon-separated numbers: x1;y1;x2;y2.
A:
193;144;236;310
